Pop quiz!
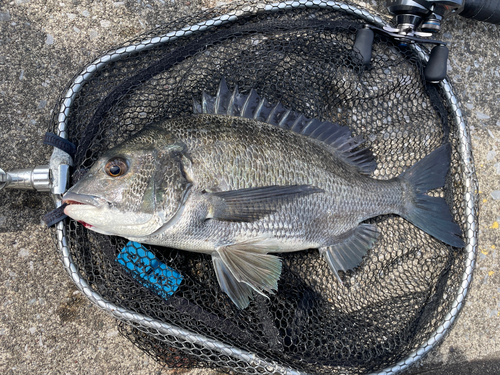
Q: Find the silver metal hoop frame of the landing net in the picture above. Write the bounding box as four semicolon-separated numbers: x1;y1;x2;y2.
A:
51;0;477;375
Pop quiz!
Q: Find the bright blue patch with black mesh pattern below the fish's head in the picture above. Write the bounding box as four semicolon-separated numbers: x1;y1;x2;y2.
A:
116;241;182;299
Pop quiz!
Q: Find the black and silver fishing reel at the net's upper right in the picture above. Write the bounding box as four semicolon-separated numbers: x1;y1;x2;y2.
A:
354;0;500;83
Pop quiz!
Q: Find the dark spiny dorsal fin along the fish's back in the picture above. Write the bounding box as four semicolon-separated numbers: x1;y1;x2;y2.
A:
193;78;377;174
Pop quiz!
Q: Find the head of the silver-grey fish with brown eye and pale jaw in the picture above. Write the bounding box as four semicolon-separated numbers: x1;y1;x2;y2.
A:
63;127;190;239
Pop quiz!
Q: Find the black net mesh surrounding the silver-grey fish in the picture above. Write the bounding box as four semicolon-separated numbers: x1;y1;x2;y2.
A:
51;2;477;374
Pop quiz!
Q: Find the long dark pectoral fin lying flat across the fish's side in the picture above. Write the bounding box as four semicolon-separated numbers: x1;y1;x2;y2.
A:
207;185;323;222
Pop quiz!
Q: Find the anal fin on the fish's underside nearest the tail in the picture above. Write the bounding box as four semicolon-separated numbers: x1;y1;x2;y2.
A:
319;224;379;283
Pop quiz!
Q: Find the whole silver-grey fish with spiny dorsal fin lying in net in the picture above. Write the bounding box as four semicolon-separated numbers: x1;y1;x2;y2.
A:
62;78;464;309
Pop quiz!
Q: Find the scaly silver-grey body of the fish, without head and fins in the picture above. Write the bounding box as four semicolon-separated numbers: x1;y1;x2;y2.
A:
126;115;403;251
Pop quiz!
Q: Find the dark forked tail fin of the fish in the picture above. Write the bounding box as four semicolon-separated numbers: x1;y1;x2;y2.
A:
399;143;465;247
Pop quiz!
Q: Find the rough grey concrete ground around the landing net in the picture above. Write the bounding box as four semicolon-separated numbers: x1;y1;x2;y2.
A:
0;0;500;374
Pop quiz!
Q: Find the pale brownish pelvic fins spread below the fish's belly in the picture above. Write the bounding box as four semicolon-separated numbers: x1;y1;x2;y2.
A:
212;241;281;309
